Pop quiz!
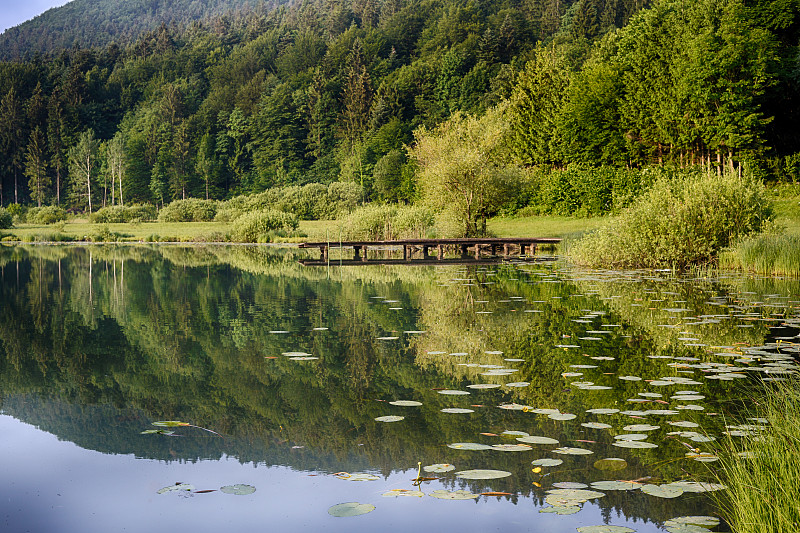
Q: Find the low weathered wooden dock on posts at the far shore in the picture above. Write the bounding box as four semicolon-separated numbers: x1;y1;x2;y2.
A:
300;237;561;262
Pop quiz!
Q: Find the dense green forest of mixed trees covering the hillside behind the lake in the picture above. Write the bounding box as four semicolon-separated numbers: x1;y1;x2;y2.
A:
0;0;800;220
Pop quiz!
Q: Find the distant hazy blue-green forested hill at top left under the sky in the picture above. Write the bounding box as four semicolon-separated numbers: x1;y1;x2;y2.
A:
0;0;276;60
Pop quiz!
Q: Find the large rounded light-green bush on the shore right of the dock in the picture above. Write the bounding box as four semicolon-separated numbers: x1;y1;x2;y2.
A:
569;172;772;269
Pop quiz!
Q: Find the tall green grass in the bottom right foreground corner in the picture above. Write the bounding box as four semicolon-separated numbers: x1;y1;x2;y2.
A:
716;379;800;533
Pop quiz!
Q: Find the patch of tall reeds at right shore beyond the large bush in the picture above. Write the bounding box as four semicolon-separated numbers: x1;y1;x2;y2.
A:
719;233;800;277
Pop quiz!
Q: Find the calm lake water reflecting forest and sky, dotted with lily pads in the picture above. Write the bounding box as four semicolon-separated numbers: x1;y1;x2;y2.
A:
0;246;800;533
